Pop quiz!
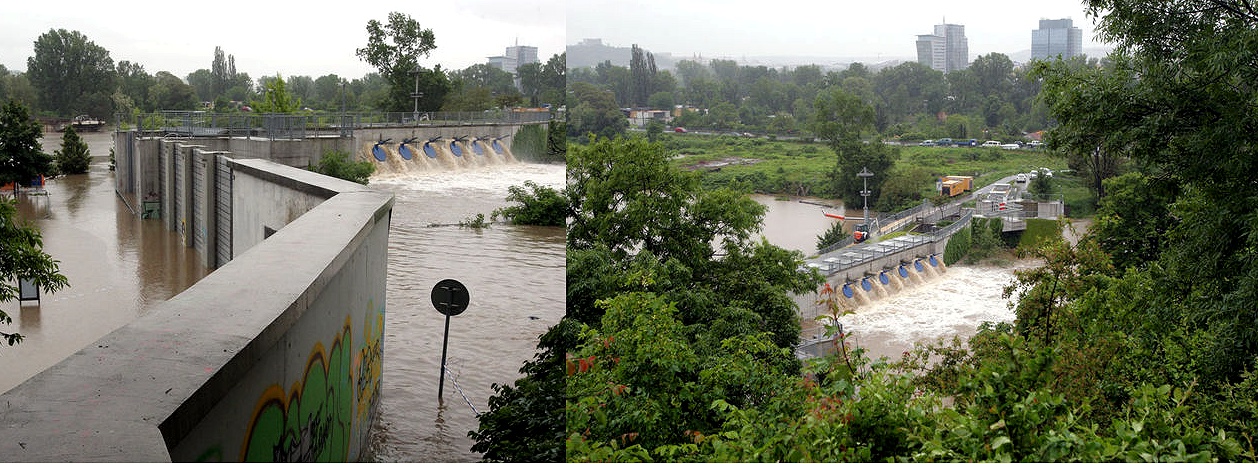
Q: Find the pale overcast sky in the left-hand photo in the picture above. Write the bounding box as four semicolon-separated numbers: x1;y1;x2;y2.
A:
0;0;565;79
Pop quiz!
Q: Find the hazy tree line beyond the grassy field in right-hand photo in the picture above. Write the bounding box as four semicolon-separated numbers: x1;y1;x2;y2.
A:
569;47;1048;141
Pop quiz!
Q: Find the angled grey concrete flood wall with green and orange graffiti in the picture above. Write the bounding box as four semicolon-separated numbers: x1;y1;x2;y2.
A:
0;132;394;461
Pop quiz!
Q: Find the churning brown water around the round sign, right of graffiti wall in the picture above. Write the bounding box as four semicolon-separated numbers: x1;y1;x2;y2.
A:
369;163;565;461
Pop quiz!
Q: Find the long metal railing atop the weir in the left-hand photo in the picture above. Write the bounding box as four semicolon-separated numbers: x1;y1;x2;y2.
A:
114;109;552;140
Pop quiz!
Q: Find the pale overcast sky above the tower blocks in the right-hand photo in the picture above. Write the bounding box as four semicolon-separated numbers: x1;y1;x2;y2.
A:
567;0;1106;64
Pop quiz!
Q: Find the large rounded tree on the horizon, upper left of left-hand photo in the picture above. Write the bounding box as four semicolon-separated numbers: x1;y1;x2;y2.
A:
26;29;114;117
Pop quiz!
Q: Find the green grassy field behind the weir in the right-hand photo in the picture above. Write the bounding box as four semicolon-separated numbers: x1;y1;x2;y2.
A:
660;133;1092;216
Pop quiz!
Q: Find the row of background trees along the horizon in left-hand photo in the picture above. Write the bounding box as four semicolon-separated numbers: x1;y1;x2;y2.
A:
0;19;566;122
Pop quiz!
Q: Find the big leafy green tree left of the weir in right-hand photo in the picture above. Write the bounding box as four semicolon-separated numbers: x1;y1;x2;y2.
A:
567;137;820;459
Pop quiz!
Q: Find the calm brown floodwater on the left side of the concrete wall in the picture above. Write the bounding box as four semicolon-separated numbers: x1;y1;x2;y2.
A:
0;132;208;391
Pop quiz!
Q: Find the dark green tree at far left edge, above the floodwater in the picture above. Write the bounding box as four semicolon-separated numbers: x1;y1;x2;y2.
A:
0;101;53;189
